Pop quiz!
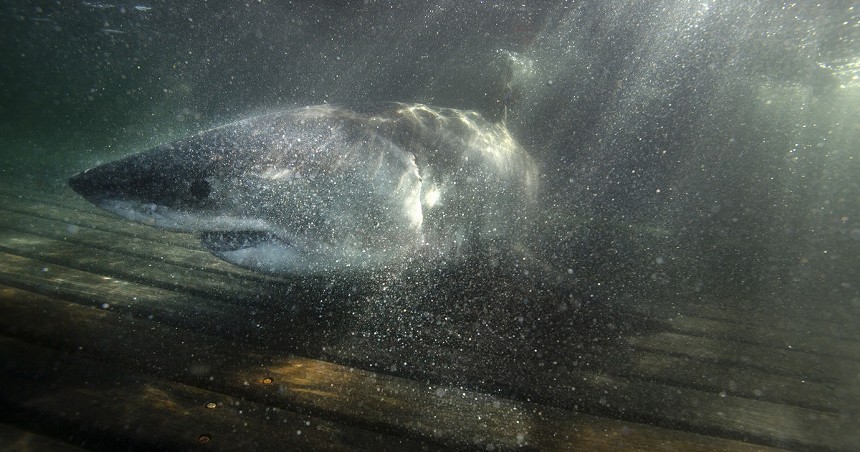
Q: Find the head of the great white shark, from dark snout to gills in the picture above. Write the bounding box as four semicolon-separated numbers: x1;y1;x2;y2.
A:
68;109;423;274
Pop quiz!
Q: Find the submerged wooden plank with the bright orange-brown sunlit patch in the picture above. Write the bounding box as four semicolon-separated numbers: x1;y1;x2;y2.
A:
0;289;784;450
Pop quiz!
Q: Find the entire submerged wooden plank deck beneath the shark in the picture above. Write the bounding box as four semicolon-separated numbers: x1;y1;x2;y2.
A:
0;185;860;451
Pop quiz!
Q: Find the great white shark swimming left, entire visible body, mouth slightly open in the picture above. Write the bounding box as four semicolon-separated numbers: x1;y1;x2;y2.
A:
69;103;538;275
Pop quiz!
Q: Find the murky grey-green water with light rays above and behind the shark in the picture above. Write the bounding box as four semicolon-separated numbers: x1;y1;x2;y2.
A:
0;0;860;428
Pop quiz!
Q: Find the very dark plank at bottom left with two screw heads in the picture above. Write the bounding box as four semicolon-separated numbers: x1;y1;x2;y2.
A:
0;337;436;451
